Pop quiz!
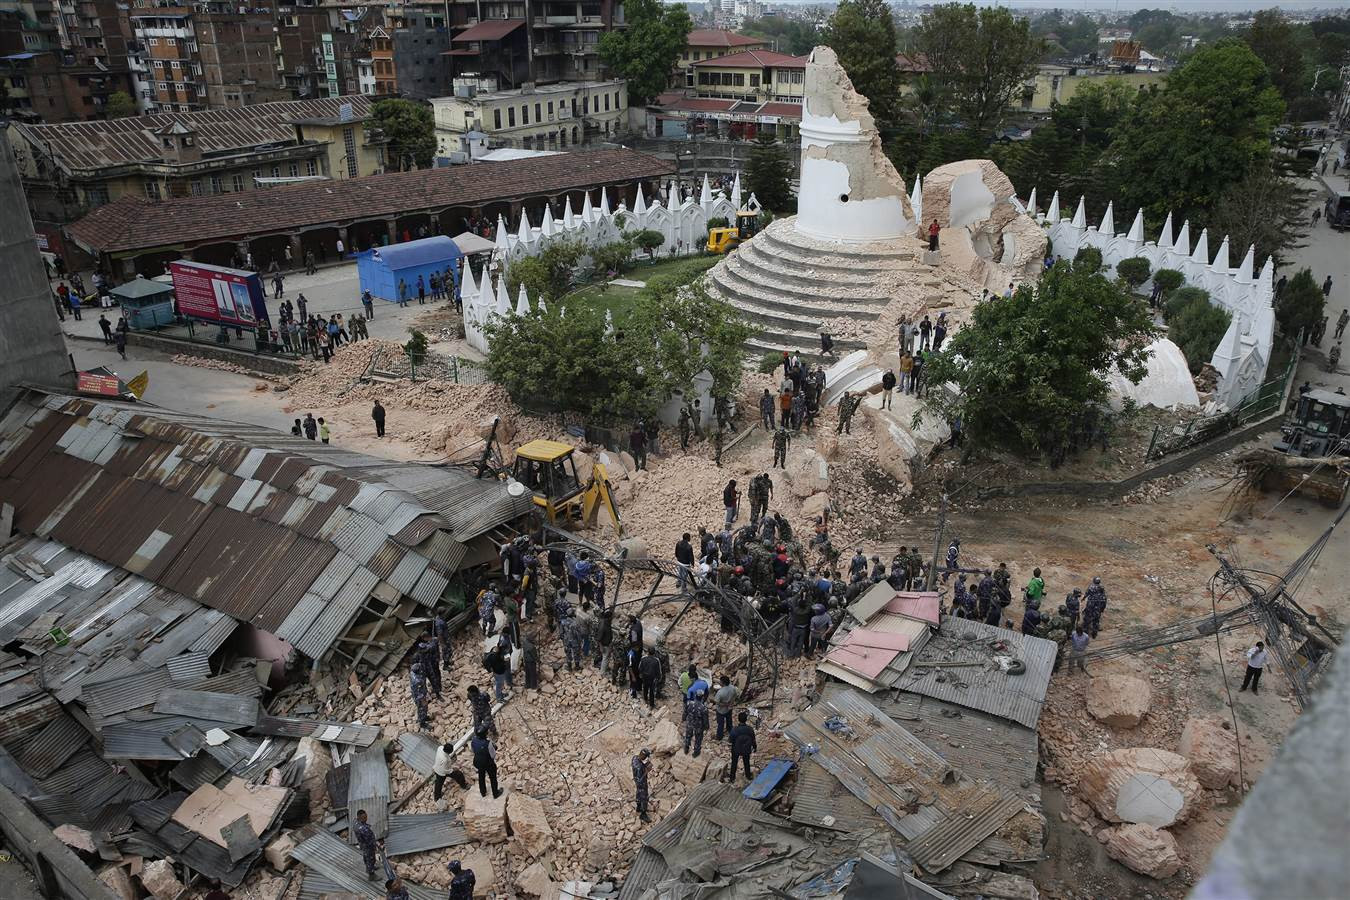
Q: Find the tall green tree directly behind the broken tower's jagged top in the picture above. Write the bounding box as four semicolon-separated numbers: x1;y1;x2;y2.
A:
821;0;900;127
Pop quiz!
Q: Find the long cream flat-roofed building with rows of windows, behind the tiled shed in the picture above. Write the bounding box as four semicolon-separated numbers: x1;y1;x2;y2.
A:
431;78;628;158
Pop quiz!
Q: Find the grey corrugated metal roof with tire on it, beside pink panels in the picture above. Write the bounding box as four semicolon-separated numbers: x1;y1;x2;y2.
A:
895;618;1058;729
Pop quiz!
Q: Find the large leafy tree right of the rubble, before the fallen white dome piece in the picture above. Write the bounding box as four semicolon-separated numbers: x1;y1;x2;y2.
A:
917;262;1157;453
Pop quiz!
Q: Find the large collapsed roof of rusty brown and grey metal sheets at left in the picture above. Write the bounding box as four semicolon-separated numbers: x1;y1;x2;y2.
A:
0;390;533;671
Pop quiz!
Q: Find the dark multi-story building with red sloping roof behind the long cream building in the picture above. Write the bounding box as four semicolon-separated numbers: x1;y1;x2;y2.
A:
446;0;625;88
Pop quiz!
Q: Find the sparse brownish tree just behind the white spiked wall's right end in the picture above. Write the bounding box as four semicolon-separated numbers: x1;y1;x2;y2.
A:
1206;161;1312;266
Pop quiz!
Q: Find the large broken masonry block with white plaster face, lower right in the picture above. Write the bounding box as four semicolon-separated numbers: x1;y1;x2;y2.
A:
1079;748;1200;827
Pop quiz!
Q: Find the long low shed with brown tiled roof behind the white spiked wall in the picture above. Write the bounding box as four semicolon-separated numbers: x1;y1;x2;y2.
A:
66;148;675;275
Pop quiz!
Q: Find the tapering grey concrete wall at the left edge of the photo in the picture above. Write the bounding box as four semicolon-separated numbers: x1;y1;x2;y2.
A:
0;127;74;390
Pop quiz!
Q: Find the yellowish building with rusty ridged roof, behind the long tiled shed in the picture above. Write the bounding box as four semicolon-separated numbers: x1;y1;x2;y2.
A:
9;96;386;242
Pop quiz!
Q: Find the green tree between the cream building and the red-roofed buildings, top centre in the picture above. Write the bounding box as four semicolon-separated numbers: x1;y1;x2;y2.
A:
599;0;694;107
